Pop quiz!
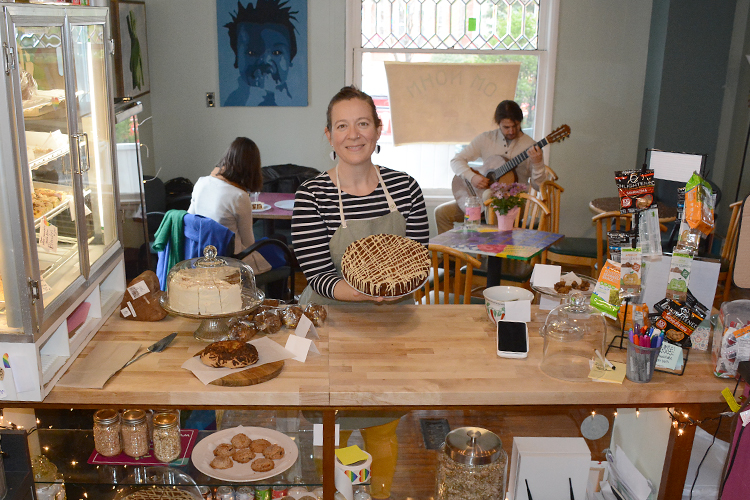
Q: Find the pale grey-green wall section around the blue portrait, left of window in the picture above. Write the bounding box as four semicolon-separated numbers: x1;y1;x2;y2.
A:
146;0;346;181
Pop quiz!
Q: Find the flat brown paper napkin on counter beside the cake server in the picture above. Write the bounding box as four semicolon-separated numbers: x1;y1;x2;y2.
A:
57;342;141;389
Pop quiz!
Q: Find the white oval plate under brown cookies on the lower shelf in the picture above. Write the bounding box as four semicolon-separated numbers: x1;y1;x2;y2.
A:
190;425;299;483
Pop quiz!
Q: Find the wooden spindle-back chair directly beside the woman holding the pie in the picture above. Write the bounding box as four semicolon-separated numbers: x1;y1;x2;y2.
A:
415;244;484;304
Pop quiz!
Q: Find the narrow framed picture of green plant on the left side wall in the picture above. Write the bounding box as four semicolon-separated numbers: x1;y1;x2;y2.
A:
111;0;151;97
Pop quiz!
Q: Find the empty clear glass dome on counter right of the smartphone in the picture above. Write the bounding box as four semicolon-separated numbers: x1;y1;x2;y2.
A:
539;292;607;382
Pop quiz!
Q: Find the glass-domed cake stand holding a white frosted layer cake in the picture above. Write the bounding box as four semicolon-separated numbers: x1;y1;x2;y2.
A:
161;245;265;342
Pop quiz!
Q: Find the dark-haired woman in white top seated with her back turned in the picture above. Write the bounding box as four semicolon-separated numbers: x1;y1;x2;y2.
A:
188;137;271;275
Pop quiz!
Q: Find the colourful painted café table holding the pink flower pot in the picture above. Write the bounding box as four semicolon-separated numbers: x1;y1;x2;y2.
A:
430;225;563;287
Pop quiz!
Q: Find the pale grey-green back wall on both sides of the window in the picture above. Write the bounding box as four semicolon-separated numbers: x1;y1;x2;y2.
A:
146;0;651;235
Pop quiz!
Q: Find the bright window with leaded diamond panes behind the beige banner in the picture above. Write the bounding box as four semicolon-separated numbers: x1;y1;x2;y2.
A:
347;0;559;196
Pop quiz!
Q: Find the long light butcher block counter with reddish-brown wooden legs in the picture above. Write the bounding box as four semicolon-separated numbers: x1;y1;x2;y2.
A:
41;304;734;499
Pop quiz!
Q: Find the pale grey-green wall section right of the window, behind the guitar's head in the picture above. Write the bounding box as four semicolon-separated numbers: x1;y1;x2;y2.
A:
550;0;651;236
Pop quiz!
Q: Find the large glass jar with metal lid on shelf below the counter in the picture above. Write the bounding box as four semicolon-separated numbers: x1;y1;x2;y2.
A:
435;427;508;500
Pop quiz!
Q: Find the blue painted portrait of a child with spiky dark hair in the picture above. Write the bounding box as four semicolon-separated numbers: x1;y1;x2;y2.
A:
216;0;308;106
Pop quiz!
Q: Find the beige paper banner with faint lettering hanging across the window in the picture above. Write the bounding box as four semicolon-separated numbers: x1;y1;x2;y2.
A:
385;62;521;146
